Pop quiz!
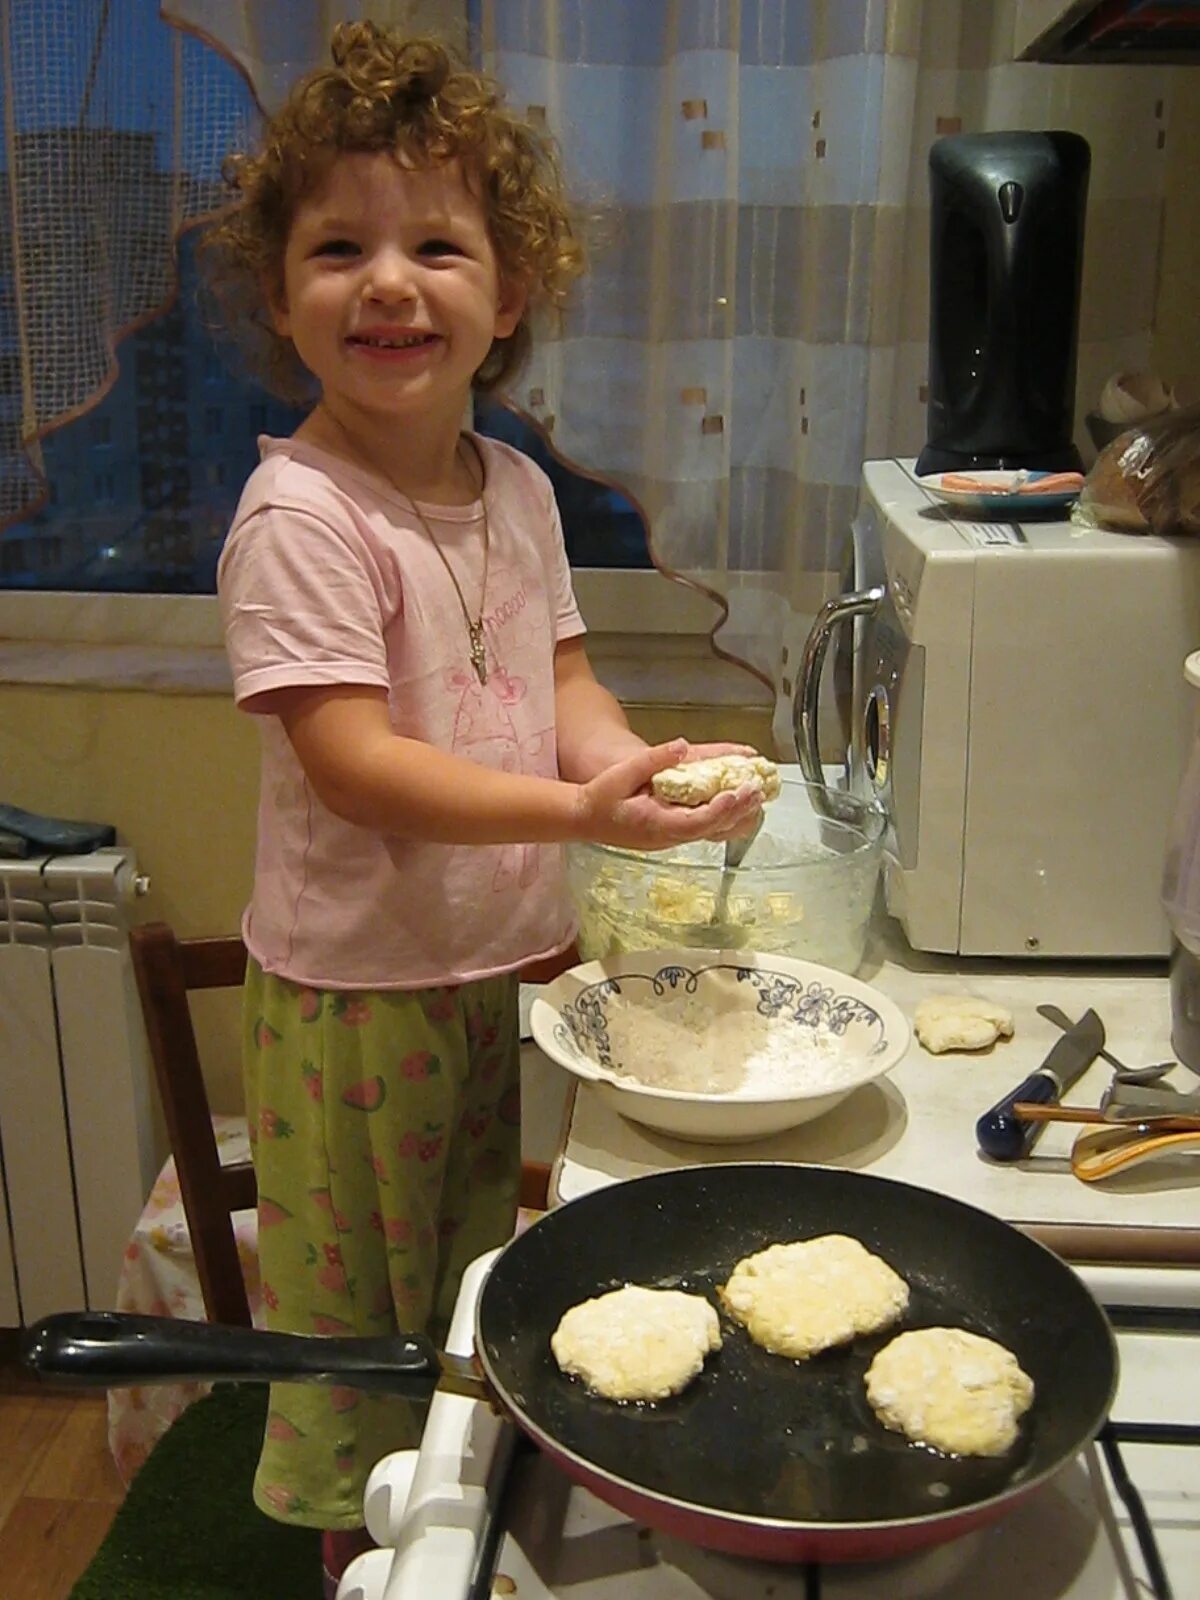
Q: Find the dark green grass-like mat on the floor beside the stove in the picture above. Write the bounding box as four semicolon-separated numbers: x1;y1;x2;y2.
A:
70;1384;320;1600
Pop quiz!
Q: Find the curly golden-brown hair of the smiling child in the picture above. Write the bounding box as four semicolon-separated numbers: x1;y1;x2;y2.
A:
200;22;584;400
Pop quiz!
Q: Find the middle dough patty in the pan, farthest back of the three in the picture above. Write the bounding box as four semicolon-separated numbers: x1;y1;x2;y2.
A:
718;1234;909;1362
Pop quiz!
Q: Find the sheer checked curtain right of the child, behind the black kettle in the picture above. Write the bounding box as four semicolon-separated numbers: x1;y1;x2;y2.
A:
482;0;1170;742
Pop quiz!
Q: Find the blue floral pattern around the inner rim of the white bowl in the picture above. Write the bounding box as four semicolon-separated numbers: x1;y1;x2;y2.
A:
554;962;891;1072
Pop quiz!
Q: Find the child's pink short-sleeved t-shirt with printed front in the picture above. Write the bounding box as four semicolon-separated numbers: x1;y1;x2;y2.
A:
218;437;584;989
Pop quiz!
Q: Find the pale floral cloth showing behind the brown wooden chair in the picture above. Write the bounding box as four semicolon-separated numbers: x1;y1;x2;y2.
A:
109;1117;261;1485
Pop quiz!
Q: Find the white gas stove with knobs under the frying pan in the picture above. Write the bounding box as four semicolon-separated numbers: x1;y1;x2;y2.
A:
338;1256;1200;1600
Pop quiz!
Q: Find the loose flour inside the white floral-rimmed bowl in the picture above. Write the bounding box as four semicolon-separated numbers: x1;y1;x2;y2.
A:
605;995;862;1094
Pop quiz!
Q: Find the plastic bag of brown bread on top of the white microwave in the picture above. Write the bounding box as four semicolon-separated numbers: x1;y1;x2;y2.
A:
1072;405;1200;534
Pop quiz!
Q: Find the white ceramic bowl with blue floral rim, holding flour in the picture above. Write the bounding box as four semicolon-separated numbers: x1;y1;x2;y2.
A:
530;949;909;1144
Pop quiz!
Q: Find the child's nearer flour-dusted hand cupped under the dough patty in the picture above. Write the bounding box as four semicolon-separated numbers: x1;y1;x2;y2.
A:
578;739;762;850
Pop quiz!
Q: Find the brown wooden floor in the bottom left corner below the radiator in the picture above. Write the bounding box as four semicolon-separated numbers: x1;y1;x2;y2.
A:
0;1339;123;1600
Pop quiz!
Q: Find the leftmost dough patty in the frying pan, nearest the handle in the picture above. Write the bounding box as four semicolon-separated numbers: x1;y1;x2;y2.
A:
550;1283;722;1400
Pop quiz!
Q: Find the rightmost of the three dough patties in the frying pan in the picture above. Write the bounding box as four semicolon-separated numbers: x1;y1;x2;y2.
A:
866;1328;1034;1456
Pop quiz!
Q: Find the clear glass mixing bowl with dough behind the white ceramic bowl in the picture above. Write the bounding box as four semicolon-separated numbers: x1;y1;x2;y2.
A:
566;778;886;973
